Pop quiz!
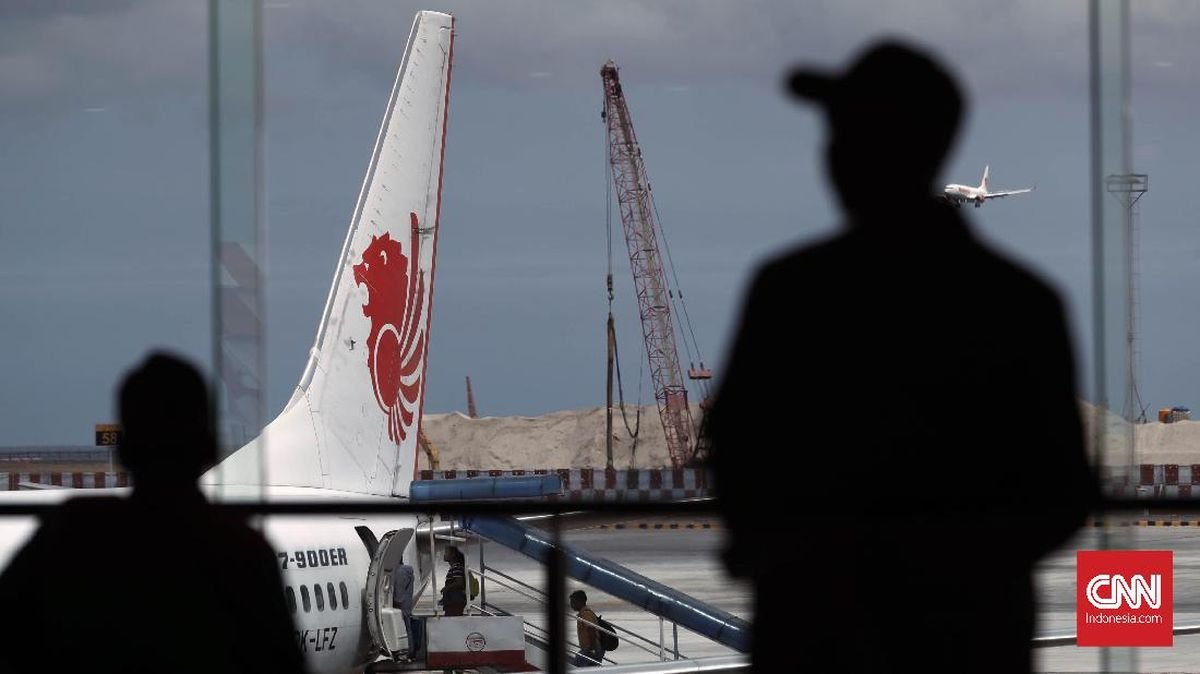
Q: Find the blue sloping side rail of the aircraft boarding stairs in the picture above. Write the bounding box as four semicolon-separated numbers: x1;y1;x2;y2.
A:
461;516;750;652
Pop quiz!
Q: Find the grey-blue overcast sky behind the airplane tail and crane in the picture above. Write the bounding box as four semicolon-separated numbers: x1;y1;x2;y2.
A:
0;0;1200;445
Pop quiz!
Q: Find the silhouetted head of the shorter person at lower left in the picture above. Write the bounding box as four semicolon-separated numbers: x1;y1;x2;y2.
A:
118;353;217;488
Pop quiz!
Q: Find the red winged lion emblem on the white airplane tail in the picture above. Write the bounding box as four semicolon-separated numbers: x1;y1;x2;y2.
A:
354;213;425;445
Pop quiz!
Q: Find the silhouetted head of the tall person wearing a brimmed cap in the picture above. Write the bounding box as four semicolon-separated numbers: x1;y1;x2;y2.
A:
787;41;965;215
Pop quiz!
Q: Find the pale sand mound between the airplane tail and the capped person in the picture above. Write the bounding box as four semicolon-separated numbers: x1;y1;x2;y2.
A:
418;405;700;470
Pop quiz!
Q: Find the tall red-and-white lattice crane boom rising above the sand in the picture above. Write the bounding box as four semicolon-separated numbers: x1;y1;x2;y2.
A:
600;61;712;468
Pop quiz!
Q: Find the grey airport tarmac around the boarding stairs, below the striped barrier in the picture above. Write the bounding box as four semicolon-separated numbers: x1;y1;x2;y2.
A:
467;518;1200;672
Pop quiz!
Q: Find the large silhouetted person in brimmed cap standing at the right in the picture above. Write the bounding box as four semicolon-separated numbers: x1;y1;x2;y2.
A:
709;42;1099;674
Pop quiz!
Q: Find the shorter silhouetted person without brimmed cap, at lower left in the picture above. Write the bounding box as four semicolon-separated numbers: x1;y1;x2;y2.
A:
0;354;304;674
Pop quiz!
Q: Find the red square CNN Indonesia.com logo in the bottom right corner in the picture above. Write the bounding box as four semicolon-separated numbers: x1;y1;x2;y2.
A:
1075;550;1174;646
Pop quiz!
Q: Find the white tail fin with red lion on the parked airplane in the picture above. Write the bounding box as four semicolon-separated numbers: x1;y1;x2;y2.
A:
202;7;454;497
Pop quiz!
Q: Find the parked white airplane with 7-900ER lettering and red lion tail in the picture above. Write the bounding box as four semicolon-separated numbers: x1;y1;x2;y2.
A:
0;11;454;674
